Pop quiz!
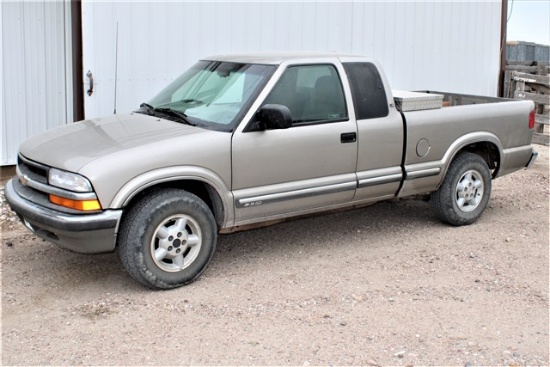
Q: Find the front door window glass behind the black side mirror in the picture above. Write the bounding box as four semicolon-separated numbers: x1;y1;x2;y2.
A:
263;65;348;124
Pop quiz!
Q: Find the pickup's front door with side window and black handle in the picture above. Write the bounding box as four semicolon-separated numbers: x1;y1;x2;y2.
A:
232;64;357;225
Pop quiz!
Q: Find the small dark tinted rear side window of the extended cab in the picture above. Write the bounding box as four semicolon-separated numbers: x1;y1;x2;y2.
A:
344;62;389;120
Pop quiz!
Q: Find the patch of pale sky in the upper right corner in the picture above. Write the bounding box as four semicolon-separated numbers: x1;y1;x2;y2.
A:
506;0;550;45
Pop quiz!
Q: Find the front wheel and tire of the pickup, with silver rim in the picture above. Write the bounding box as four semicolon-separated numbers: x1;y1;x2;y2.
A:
117;189;217;289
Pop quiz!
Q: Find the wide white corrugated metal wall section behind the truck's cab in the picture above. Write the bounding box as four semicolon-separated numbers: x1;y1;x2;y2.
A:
83;1;501;117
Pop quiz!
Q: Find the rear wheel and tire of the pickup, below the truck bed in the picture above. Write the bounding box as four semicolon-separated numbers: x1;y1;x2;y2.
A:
431;153;491;226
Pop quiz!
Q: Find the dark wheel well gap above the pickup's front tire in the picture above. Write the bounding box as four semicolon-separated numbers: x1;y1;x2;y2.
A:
125;180;225;229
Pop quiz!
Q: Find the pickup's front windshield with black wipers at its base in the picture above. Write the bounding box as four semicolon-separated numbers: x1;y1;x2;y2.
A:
136;61;275;131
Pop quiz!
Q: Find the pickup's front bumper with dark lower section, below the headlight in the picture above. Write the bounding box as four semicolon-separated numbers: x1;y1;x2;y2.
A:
4;178;122;254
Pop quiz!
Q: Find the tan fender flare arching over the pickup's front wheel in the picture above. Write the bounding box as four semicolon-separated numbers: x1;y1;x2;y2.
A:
109;166;235;227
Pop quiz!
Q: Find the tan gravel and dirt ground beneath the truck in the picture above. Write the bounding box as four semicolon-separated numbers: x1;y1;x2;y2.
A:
0;146;550;366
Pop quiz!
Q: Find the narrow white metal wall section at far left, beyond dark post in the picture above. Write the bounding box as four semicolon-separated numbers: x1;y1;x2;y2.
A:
0;1;72;165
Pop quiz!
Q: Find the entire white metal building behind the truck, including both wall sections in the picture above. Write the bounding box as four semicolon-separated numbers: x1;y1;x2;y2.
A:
0;0;506;165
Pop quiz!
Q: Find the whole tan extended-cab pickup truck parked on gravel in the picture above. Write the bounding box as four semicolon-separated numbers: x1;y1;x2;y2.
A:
5;53;536;289
